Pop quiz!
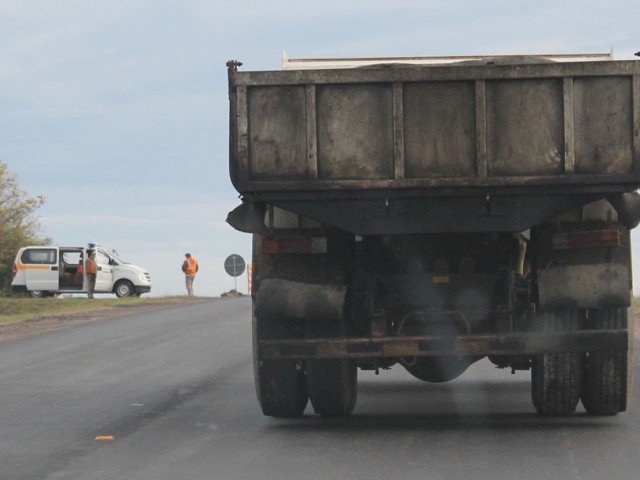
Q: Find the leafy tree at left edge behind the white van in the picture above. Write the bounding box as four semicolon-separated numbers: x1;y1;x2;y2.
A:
0;161;50;296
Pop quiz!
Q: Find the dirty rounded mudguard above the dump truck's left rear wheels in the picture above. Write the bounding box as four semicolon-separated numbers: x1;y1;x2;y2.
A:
255;278;347;321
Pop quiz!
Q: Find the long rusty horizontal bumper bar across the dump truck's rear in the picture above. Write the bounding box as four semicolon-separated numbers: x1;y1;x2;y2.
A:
258;329;628;360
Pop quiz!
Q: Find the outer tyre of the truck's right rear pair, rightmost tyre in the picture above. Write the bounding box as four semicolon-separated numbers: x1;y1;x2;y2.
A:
582;307;628;415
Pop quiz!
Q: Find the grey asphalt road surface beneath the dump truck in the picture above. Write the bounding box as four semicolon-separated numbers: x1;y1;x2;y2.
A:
0;299;640;480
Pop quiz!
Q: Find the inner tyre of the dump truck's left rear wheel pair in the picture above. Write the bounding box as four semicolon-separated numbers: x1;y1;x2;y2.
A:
307;322;358;417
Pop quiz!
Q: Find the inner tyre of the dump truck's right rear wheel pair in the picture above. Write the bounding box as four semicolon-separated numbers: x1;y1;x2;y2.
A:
531;308;584;415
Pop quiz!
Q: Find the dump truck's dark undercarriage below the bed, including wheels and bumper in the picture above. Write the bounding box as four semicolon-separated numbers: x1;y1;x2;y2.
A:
245;202;630;417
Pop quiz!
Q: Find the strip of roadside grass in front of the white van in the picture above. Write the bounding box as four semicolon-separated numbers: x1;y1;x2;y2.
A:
0;296;195;325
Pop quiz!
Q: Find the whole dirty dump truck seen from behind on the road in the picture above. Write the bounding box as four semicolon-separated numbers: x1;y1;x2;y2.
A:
227;55;640;418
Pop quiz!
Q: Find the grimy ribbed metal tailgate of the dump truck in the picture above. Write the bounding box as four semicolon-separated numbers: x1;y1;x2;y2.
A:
229;61;640;198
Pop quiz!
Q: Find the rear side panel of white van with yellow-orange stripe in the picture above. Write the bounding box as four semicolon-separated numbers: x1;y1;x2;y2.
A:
18;247;60;292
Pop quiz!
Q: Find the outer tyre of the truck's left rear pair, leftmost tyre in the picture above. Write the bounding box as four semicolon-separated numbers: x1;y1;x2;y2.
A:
253;314;309;418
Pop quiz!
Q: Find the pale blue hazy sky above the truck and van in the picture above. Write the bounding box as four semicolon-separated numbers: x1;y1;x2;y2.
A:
0;0;640;296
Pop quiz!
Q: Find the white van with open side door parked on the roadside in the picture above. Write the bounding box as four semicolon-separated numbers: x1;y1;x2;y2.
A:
11;244;151;297
